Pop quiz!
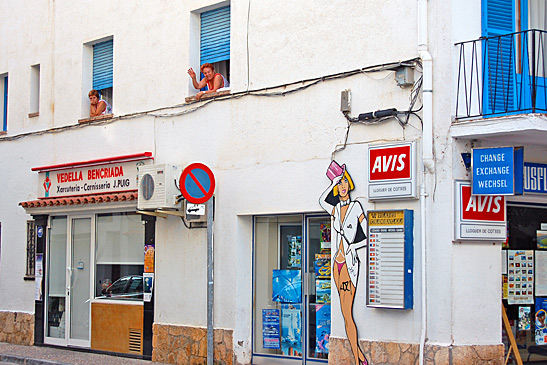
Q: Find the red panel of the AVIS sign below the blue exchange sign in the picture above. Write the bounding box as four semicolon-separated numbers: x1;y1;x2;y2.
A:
461;186;505;222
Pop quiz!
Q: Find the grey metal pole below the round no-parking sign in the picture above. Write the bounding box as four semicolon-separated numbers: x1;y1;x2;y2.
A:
207;197;215;365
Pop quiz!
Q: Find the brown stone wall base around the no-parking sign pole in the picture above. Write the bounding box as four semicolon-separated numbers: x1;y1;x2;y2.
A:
152;324;234;365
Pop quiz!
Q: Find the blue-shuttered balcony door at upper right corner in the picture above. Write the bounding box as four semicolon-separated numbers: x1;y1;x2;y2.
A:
482;0;547;116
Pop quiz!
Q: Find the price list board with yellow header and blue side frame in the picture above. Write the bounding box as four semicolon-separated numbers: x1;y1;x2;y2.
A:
367;209;414;309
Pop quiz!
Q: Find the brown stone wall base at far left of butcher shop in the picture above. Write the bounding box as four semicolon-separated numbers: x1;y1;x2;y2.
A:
0;312;34;346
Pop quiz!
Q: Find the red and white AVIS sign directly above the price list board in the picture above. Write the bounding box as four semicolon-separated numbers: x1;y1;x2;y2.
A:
368;142;416;200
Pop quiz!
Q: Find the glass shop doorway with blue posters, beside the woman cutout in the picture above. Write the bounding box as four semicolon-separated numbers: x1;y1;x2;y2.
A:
253;214;331;364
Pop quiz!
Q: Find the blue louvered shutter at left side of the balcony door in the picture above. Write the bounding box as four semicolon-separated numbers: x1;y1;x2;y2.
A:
482;0;516;114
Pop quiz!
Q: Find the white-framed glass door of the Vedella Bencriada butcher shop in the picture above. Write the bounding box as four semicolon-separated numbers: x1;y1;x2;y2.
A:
44;216;94;347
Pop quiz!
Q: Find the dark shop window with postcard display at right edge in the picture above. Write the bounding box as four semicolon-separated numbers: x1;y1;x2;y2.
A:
508;204;547;362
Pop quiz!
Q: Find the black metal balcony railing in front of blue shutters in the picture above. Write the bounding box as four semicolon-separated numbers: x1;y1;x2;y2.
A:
456;30;547;119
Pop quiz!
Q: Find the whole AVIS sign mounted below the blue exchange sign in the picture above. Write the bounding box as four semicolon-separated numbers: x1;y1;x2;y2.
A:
454;181;507;241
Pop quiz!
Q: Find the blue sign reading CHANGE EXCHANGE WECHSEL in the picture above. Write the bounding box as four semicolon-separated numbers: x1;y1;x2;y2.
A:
471;147;524;195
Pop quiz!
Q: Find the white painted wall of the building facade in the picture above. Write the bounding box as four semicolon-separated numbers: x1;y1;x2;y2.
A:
0;0;524;361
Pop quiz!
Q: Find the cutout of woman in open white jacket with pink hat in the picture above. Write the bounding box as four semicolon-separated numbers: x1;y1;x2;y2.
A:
319;161;368;365
